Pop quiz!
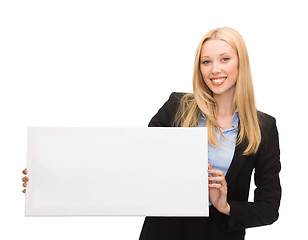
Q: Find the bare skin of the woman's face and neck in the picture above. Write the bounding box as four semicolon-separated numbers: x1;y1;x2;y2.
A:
200;40;238;130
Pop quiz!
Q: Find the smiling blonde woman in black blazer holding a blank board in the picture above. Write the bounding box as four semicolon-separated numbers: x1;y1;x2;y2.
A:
140;27;281;240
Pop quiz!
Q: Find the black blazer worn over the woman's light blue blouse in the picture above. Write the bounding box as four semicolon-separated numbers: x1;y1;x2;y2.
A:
139;93;281;240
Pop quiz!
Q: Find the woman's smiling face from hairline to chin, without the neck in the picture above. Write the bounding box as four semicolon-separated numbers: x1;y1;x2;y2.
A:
200;40;238;97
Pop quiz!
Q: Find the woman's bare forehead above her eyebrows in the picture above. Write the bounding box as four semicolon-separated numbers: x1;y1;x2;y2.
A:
201;40;236;57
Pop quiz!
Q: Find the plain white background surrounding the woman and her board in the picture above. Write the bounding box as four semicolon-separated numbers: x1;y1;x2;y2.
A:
0;0;308;240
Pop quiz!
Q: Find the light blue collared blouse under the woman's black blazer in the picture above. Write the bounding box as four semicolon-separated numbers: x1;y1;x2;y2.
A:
198;110;239;205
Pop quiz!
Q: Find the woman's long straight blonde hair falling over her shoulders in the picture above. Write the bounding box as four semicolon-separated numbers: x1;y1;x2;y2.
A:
175;27;261;155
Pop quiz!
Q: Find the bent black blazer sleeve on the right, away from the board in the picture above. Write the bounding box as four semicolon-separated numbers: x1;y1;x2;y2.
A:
227;115;281;231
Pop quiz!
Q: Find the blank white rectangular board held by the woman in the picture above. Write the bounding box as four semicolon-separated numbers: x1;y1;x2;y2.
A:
25;127;208;216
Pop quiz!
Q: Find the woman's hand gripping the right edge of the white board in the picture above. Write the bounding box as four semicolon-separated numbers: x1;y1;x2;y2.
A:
208;164;230;215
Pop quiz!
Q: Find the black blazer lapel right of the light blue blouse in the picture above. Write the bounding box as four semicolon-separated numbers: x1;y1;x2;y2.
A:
226;143;247;185
